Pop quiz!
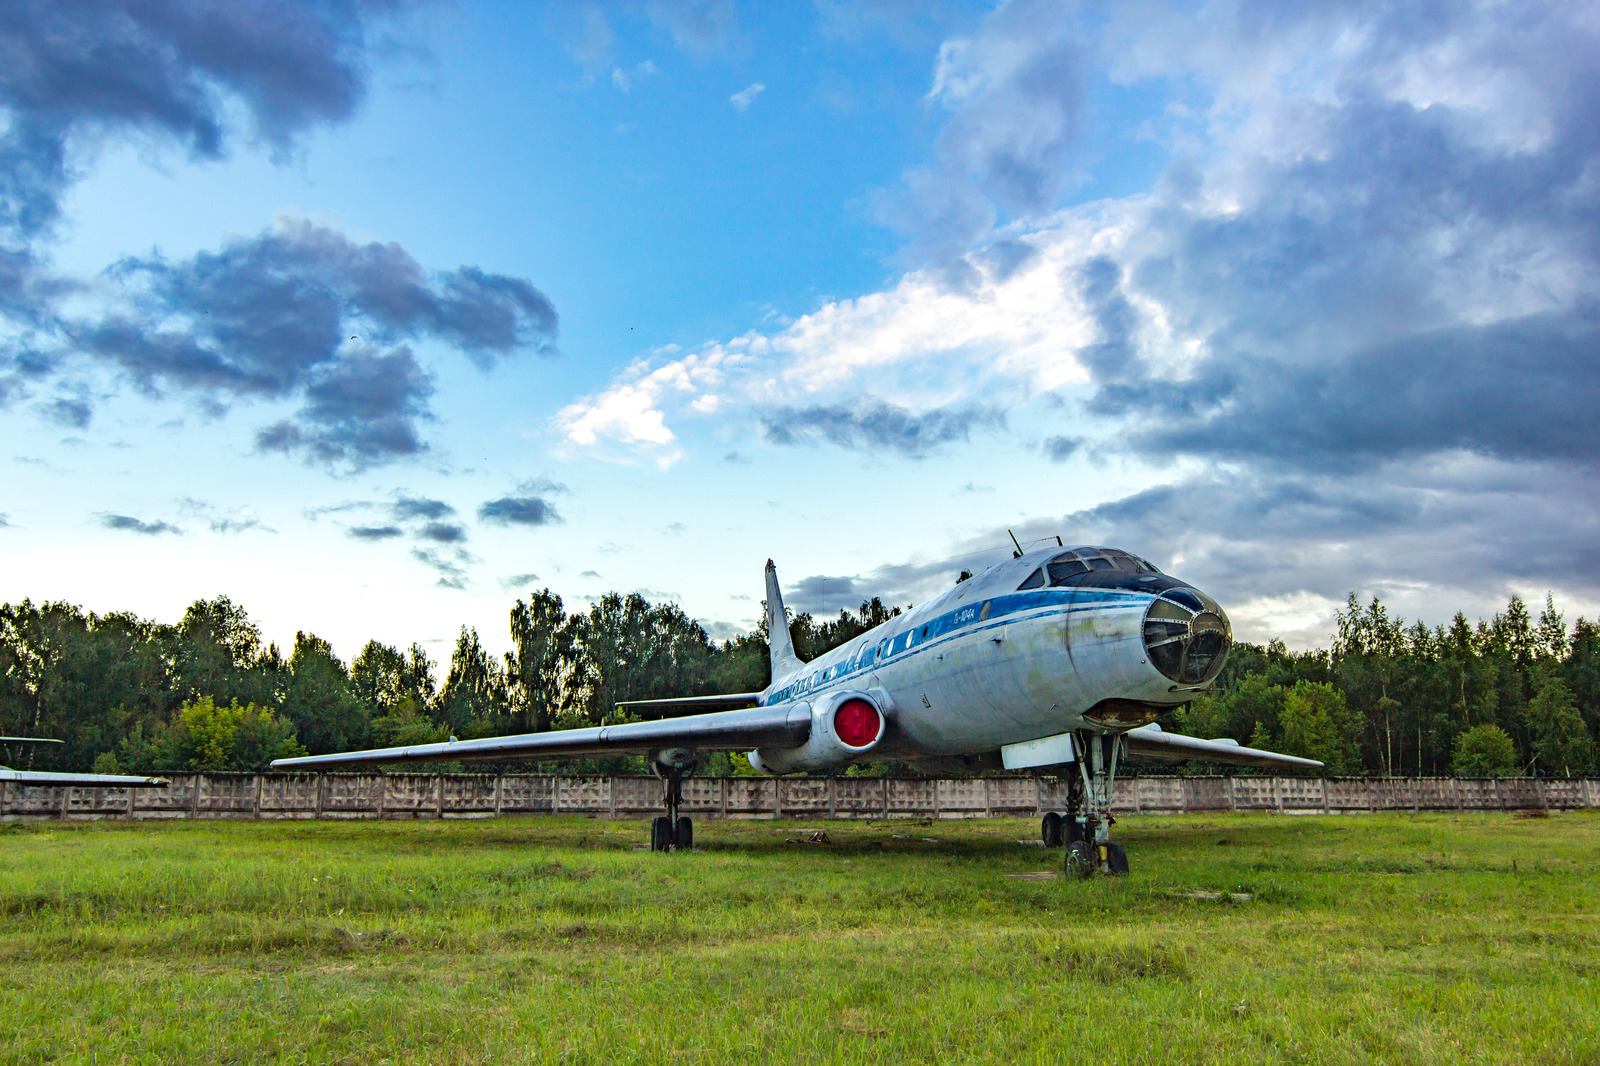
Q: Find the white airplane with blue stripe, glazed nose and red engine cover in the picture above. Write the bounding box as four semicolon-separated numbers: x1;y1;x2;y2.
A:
272;538;1323;877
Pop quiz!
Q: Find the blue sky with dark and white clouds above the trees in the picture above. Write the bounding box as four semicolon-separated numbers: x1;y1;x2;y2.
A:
0;0;1600;658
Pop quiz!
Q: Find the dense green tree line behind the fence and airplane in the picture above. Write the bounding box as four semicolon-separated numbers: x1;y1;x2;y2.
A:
0;585;1600;776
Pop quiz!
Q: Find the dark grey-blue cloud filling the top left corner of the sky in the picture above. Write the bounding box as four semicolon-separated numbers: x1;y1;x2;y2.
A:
0;0;398;240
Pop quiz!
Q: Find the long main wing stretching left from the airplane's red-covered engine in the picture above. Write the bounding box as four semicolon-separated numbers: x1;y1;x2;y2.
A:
272;703;811;770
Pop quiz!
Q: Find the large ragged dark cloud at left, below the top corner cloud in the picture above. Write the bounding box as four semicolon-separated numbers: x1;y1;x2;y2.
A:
70;219;555;467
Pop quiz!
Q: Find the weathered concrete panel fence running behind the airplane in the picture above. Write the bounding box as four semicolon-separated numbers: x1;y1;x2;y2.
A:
0;773;1600;821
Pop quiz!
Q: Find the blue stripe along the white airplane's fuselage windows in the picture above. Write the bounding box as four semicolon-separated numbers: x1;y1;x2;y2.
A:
762;589;1154;706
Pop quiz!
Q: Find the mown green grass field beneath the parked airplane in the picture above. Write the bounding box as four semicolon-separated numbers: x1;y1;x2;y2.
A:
0;813;1600;1064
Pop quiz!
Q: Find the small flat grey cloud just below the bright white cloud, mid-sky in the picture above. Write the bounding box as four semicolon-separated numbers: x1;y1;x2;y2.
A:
762;397;1005;459
